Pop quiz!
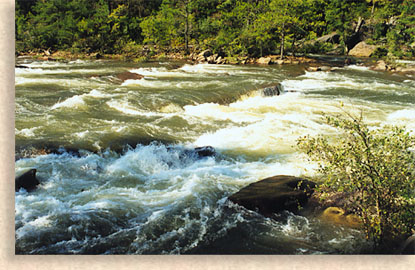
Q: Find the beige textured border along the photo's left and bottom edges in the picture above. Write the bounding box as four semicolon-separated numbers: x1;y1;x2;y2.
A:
0;0;415;270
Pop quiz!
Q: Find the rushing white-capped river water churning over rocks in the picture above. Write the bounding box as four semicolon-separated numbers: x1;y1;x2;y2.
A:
15;57;415;254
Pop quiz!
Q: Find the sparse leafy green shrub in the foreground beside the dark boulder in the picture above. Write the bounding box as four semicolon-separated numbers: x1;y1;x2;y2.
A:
298;115;415;247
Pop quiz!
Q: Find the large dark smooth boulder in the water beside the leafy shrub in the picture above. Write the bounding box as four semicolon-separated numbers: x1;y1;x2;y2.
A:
229;175;316;216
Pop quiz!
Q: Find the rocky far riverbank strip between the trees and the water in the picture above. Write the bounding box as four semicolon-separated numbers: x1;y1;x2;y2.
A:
16;50;415;76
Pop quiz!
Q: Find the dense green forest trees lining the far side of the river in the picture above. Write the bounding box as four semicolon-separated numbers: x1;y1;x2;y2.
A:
15;0;415;58
